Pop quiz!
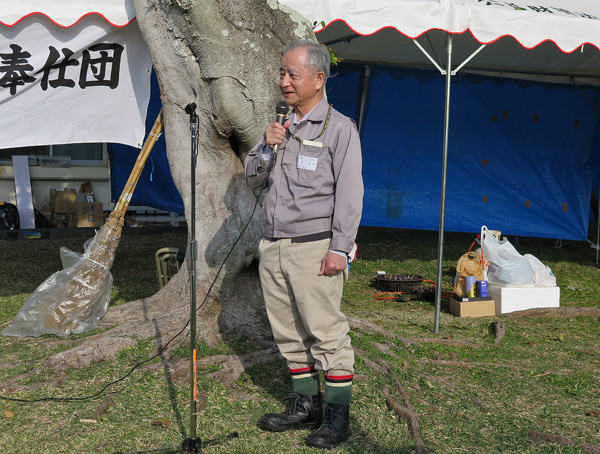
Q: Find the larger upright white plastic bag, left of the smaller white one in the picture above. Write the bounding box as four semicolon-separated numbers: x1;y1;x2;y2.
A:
481;225;534;284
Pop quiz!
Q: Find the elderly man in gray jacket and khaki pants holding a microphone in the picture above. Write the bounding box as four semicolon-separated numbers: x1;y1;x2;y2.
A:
246;40;363;449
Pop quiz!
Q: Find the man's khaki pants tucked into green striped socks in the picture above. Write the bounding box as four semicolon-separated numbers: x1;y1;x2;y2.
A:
259;239;354;376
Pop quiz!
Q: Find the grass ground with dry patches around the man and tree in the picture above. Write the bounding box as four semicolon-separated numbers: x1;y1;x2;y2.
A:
0;228;600;454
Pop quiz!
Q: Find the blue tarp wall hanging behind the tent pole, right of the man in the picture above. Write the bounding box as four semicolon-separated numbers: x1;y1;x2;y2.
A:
328;63;600;240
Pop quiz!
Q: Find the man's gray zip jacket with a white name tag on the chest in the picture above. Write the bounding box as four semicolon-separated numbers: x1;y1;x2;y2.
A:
245;99;364;253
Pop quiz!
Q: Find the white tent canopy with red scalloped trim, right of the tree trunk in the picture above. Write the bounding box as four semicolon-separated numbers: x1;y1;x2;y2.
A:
280;0;600;84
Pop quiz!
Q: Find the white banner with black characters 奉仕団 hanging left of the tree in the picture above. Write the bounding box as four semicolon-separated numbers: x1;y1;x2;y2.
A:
0;15;152;148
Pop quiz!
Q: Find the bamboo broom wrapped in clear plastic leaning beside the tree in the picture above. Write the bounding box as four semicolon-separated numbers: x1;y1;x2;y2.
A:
2;110;163;337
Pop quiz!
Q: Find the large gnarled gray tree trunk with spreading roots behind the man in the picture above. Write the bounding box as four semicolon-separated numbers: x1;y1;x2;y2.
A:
44;0;314;368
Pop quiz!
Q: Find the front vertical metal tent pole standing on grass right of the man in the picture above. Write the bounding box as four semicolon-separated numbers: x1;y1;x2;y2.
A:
434;33;452;334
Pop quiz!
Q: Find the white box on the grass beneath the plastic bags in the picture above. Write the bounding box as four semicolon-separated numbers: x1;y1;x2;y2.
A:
488;282;560;314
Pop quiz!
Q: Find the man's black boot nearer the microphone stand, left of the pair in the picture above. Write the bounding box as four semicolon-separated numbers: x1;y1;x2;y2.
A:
258;393;323;432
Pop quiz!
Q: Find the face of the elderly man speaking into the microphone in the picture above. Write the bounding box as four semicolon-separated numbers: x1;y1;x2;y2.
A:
279;47;325;114
